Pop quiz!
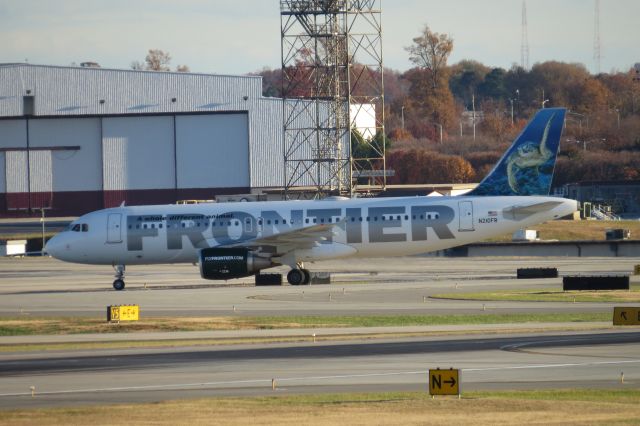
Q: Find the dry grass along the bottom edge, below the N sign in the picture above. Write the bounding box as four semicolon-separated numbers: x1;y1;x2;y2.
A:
0;391;640;426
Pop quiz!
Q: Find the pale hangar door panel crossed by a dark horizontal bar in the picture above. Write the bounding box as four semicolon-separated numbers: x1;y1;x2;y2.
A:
29;118;102;191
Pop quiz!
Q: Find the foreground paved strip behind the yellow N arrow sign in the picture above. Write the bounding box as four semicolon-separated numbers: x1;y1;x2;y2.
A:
0;331;640;408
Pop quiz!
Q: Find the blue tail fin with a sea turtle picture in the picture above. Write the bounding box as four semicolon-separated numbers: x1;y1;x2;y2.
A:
465;108;566;195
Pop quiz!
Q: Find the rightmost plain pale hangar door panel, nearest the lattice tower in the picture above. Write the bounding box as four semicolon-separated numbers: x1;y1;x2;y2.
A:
176;113;250;189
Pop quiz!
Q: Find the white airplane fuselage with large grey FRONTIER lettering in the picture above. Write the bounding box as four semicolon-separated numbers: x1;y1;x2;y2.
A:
46;196;577;265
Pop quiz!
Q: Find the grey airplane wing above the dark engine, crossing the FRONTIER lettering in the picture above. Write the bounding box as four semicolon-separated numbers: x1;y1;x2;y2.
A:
224;223;338;254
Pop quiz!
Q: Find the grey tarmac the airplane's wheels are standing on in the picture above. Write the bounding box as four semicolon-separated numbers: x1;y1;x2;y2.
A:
0;257;640;317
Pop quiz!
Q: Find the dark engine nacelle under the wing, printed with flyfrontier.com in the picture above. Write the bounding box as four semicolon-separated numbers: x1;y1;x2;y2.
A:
200;248;273;280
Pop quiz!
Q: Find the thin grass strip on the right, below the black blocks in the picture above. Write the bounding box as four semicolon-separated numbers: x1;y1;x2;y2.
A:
431;285;640;303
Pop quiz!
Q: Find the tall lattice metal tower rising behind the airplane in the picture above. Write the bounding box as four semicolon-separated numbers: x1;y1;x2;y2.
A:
280;0;386;197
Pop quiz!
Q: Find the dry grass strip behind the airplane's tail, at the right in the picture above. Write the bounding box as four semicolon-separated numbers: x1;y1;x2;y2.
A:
487;220;640;242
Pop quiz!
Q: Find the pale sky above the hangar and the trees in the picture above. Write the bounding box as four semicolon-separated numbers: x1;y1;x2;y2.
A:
0;0;640;74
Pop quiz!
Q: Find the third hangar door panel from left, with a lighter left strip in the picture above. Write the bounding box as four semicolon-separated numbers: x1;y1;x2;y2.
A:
102;117;175;190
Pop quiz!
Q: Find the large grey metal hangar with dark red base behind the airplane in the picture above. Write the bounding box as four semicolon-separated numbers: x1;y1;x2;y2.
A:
0;64;312;217
